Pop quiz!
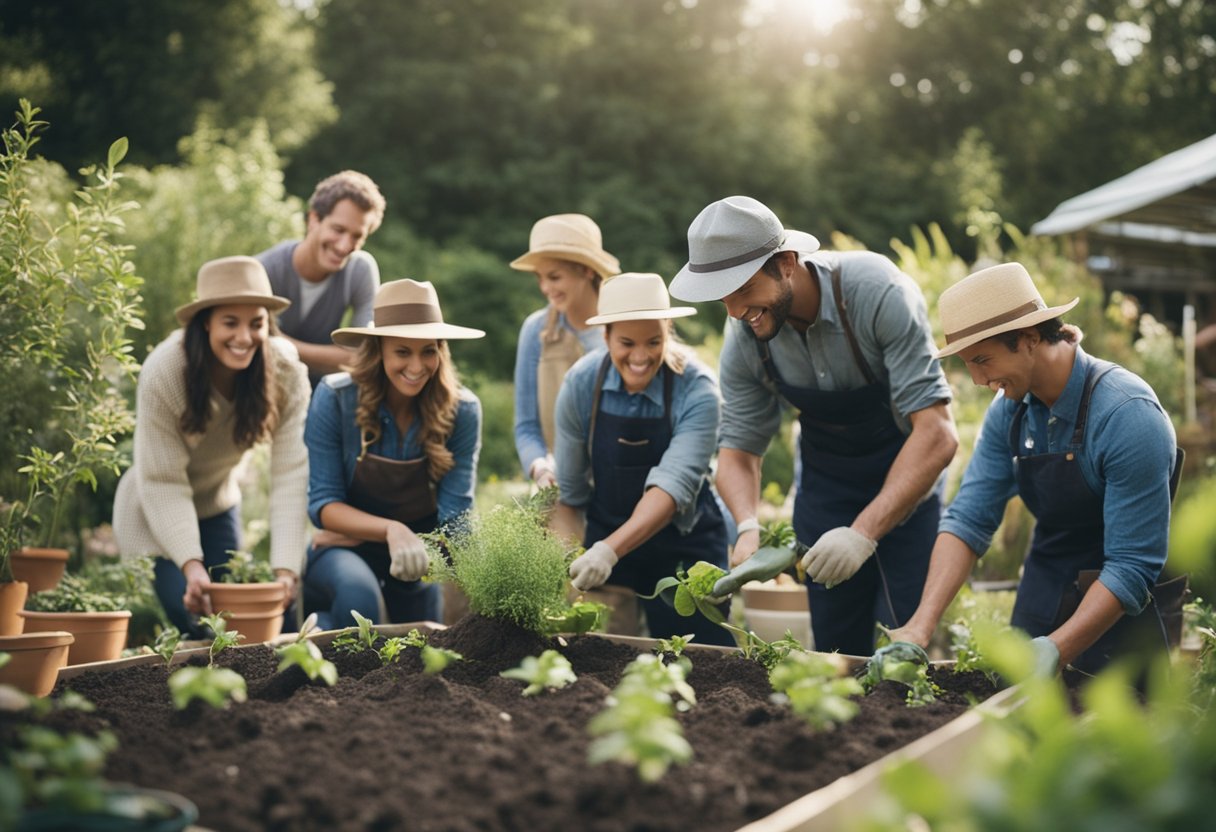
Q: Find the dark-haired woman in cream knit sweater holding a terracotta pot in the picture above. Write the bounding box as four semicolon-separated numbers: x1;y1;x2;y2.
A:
114;257;309;636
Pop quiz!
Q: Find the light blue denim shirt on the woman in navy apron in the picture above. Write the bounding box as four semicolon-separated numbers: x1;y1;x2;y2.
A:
554;349;721;534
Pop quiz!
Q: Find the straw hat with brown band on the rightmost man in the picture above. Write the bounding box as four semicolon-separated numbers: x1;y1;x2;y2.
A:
936;263;1080;358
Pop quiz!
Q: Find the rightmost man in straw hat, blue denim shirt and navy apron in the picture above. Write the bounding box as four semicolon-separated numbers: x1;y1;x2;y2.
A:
893;263;1181;675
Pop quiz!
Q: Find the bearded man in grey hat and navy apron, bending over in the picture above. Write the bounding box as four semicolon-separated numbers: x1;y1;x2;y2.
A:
670;196;958;656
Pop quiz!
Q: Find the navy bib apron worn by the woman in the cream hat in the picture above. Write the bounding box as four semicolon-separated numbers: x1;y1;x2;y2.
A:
582;355;734;647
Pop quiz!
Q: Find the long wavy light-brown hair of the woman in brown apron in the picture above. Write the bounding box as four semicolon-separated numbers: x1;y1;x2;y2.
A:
347;337;460;482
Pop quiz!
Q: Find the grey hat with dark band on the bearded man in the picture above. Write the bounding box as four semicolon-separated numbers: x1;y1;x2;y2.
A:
671;196;820;302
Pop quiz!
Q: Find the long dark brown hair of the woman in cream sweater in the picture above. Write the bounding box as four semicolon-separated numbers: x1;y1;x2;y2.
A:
178;309;278;449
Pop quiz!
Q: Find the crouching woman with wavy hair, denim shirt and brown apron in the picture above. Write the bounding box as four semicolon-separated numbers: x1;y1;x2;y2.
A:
304;280;485;629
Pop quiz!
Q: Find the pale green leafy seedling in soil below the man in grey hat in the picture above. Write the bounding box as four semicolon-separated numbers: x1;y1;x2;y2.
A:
769;651;865;729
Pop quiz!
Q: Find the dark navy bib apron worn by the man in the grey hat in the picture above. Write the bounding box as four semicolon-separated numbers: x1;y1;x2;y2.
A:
756;263;944;656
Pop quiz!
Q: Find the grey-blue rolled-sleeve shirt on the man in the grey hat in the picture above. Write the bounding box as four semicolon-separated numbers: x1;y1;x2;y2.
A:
719;252;951;456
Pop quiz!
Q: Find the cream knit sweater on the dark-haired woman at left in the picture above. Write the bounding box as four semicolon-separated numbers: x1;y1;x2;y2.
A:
114;330;310;574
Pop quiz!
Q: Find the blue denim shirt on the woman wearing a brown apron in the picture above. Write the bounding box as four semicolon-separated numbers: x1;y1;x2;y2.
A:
304;372;482;528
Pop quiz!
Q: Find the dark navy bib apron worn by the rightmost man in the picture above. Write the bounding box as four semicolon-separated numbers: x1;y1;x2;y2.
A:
1009;360;1186;674
